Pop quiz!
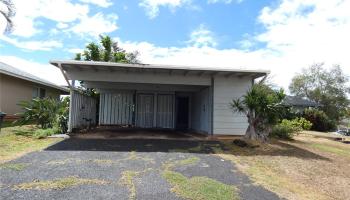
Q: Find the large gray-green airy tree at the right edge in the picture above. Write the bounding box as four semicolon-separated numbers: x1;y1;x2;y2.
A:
289;63;350;121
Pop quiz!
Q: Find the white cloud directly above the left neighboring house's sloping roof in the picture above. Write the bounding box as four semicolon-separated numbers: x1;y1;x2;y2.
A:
0;56;67;85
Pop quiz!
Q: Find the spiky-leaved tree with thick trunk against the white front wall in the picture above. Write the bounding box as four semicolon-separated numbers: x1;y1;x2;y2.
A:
231;83;285;142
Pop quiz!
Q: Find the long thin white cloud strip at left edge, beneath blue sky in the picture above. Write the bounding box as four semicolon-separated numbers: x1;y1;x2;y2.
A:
0;35;63;51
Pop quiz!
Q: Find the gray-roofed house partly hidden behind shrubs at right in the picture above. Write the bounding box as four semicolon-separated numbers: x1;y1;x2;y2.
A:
282;96;320;112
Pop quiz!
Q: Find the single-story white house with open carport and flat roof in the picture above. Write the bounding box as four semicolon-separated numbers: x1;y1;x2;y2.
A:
50;60;269;135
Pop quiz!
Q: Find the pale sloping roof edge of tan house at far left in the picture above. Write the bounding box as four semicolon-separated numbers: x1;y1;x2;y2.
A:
0;62;69;92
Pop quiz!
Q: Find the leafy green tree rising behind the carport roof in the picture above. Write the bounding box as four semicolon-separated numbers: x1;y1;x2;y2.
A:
75;35;139;63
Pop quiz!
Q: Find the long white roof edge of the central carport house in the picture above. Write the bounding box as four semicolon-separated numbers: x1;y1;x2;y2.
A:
50;60;270;77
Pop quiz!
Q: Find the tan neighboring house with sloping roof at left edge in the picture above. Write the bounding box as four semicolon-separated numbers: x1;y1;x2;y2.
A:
0;62;69;119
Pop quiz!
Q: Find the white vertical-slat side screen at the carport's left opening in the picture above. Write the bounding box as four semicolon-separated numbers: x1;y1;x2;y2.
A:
68;90;97;132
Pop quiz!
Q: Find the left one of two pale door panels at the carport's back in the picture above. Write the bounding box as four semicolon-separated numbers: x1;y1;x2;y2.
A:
137;94;154;128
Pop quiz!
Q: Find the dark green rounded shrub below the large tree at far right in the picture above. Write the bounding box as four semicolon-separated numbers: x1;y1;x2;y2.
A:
303;108;336;131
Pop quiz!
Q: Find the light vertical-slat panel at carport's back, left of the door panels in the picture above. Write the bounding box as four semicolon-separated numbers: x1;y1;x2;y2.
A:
100;92;134;125
